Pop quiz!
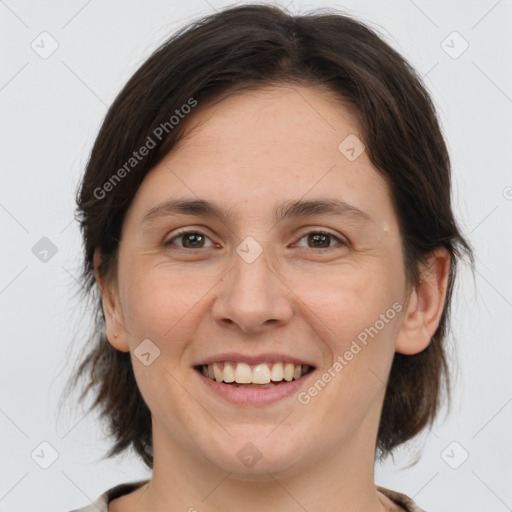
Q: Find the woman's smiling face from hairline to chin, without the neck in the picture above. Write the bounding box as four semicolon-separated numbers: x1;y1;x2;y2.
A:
97;85;428;478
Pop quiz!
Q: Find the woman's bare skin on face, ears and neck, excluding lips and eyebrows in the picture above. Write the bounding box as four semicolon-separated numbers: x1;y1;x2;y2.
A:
95;84;449;512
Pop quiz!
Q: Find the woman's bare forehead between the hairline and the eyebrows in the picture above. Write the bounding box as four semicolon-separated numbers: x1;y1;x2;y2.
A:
122;85;391;232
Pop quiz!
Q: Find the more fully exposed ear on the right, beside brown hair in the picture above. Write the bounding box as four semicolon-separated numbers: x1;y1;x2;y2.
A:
395;247;450;355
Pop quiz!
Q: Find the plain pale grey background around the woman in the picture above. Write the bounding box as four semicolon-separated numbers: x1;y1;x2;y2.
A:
0;0;512;512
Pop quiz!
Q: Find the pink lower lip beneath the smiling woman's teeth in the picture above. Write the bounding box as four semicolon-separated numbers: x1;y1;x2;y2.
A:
194;370;315;405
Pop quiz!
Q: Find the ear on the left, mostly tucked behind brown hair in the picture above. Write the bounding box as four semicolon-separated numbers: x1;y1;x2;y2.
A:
93;248;130;352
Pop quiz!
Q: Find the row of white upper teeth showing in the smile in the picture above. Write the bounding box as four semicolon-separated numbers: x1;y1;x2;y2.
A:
201;361;309;387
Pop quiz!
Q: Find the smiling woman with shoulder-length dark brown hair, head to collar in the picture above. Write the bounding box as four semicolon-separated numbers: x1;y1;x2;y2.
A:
66;5;472;512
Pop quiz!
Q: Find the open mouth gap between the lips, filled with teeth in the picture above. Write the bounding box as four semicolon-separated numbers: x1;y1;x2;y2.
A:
194;361;315;390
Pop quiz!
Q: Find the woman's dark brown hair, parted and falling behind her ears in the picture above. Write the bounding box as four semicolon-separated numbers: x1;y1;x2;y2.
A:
62;5;474;467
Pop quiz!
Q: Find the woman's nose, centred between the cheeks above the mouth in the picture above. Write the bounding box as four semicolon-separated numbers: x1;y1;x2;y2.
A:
212;242;293;333
